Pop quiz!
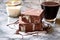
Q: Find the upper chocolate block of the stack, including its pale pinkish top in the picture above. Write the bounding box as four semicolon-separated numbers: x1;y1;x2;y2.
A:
21;9;43;23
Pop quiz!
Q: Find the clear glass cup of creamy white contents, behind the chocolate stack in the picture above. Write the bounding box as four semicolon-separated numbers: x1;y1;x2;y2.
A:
6;0;22;17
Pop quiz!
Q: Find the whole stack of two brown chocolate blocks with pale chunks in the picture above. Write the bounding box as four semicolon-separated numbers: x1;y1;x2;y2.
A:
15;9;43;32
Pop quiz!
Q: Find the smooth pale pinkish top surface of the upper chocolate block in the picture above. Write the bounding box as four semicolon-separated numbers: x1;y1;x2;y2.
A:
21;9;43;16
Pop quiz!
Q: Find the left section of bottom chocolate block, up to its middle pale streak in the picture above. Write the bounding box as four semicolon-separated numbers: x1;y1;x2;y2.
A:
19;23;33;32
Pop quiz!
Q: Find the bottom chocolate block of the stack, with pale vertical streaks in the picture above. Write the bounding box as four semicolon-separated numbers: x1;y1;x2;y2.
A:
19;23;43;32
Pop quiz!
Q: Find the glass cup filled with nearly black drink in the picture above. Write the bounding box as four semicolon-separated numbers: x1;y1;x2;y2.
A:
41;1;59;21
